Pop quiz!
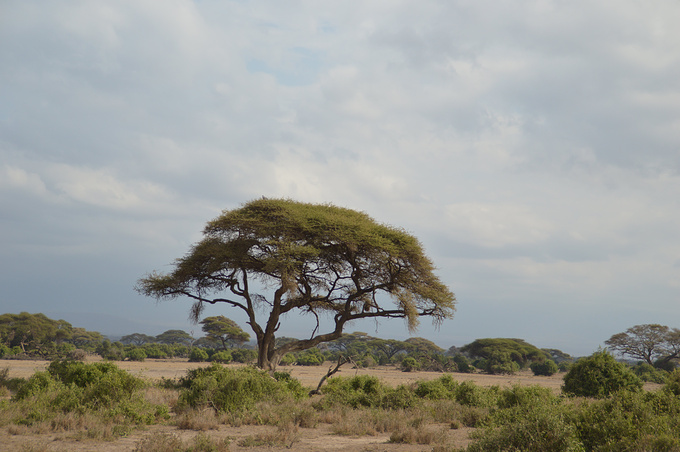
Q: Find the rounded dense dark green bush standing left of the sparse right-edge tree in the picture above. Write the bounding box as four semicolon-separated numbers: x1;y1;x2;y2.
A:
562;351;642;398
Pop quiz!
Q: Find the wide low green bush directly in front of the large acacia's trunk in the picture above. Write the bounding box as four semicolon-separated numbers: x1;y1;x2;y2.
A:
178;364;305;412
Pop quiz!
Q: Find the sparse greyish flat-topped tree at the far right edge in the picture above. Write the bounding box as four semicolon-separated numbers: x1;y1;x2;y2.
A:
605;323;680;365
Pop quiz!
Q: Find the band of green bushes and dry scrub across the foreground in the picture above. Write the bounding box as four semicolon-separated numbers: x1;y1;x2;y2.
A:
0;352;680;452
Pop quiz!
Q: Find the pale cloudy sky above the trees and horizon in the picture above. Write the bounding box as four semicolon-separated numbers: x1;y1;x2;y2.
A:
0;0;680;356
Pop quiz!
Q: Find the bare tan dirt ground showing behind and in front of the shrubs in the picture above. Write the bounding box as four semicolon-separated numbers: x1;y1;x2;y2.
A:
0;358;580;452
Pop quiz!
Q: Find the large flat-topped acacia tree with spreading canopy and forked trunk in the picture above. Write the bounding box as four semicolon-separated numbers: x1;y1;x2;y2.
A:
136;198;455;371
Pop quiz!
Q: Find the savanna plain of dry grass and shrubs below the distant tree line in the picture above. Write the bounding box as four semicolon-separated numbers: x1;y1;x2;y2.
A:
0;357;680;452
